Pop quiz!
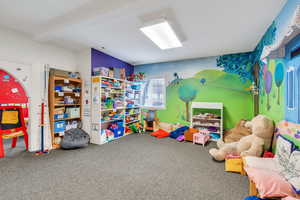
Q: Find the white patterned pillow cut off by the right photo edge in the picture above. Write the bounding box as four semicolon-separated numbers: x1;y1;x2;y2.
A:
283;149;300;194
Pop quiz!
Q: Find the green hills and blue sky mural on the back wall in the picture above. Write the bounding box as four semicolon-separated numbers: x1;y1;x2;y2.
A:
135;57;253;128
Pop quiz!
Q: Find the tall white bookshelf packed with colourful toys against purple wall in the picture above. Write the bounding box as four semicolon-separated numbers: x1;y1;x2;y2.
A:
91;76;141;145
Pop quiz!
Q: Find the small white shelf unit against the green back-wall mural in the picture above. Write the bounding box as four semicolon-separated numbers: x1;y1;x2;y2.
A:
190;102;223;141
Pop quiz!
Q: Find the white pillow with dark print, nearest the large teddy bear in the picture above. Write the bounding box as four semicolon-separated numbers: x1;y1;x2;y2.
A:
275;135;294;173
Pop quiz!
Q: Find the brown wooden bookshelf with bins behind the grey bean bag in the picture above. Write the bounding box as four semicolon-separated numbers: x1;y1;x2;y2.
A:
48;74;82;149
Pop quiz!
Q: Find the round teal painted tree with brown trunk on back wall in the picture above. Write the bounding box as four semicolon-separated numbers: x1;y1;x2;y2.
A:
178;84;197;121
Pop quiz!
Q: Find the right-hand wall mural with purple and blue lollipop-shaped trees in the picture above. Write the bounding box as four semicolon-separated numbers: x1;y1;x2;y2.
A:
254;0;300;122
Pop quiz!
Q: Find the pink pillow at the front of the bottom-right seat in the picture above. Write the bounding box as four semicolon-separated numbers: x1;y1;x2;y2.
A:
245;167;295;198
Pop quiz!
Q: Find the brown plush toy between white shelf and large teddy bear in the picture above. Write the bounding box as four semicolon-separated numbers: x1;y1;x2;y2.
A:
224;120;251;143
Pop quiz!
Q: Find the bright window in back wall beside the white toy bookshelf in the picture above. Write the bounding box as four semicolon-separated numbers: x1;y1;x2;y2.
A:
141;79;166;110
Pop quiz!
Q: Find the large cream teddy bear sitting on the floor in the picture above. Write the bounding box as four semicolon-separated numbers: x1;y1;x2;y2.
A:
209;115;274;161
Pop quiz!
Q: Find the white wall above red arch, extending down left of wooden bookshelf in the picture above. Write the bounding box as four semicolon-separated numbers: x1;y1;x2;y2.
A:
0;28;78;151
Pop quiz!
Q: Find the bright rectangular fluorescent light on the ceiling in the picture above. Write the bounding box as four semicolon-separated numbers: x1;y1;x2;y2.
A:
140;21;182;50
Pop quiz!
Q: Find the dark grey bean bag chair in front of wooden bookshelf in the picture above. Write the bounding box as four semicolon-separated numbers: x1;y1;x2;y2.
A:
60;128;90;150
